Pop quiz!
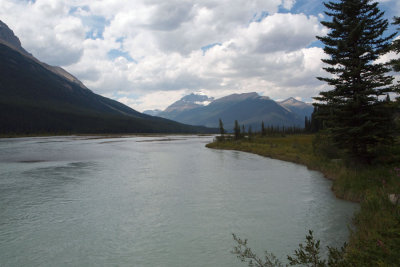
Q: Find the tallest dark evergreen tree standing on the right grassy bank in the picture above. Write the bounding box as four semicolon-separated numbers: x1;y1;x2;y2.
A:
315;0;394;159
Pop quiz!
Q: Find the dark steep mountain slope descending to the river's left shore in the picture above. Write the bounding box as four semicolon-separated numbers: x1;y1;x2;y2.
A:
0;23;214;134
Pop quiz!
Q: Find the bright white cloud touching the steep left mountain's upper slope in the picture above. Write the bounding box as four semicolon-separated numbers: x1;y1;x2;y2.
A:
0;0;85;66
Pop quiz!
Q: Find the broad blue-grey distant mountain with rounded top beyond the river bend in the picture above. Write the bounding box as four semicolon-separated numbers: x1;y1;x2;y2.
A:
159;93;312;131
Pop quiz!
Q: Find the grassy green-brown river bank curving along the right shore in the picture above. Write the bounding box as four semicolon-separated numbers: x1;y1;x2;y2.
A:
207;135;400;266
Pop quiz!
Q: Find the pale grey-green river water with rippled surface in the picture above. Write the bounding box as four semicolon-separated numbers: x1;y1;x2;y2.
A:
0;136;357;267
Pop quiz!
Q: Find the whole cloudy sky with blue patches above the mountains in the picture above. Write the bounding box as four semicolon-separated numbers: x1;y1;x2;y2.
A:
0;0;400;111
